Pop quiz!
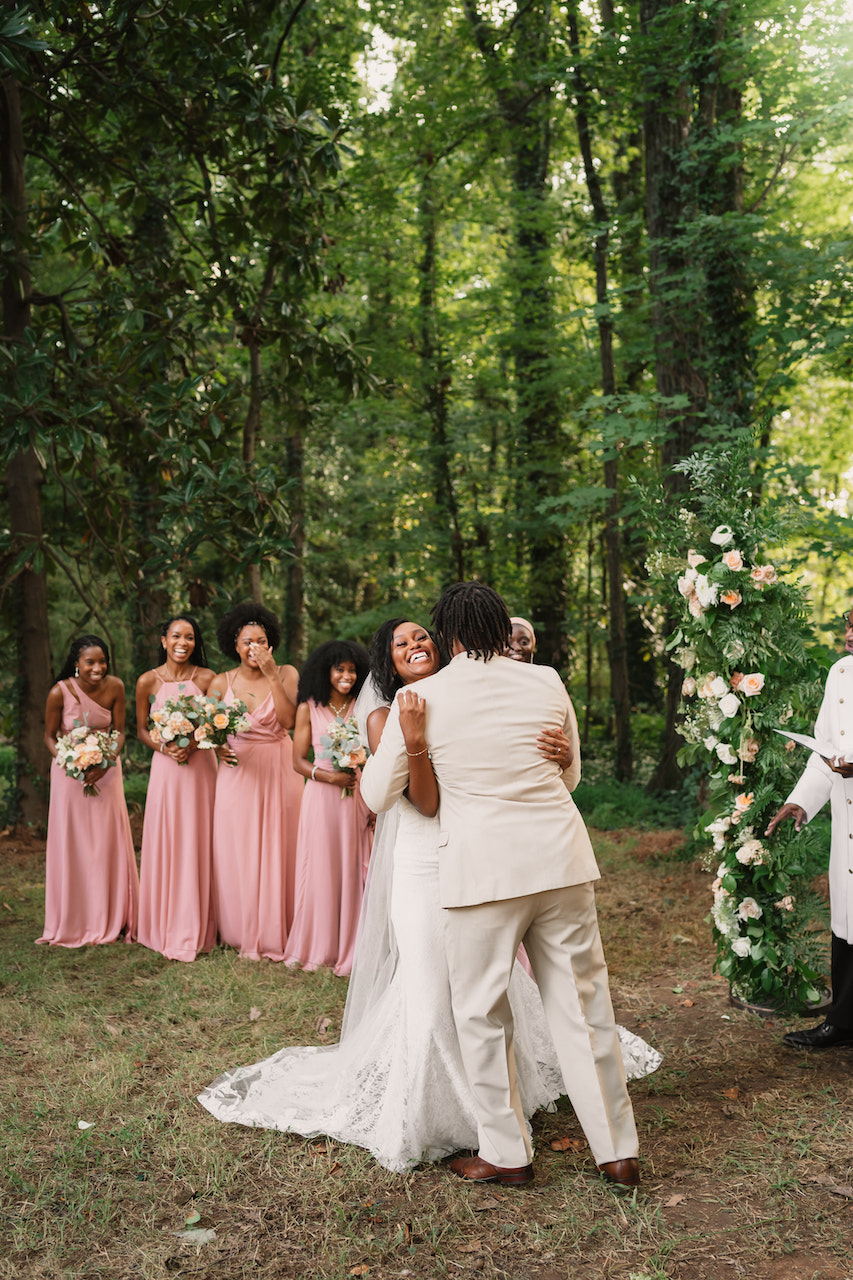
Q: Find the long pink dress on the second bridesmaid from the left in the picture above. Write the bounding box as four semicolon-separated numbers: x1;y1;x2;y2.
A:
136;671;216;960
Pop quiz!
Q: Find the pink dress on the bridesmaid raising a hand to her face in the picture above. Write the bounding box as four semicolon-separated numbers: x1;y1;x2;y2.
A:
214;673;302;960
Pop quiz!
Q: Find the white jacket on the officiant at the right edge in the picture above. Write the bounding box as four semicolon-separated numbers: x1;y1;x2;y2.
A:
788;654;853;942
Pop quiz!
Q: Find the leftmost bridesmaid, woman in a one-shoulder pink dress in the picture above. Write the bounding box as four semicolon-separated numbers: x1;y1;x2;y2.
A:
37;635;138;947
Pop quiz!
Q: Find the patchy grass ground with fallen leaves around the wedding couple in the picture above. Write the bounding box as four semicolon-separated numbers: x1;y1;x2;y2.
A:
0;831;853;1280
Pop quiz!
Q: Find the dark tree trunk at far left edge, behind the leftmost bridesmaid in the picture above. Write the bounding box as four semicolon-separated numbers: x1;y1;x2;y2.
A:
0;77;51;824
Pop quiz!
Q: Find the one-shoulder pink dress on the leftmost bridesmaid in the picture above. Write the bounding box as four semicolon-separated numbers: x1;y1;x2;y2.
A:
36;680;140;947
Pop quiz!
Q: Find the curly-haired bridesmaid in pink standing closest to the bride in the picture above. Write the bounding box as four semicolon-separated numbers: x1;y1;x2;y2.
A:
287;640;373;978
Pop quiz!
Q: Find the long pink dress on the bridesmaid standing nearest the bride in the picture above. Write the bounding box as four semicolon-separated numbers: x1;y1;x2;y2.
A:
286;699;373;978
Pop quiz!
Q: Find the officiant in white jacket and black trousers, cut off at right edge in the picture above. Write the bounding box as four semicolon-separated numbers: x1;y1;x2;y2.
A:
765;609;853;1048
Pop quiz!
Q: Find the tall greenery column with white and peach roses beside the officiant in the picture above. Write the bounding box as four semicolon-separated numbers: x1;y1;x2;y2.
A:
649;445;827;1011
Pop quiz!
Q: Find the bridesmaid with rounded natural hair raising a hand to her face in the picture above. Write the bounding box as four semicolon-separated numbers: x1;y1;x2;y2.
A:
209;603;302;960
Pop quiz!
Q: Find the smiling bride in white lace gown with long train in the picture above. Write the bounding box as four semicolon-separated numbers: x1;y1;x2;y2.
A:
199;618;661;1172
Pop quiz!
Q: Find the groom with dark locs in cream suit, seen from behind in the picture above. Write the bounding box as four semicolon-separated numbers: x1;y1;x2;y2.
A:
361;582;639;1188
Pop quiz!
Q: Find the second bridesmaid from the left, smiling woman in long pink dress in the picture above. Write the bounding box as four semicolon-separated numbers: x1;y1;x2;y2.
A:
136;613;216;960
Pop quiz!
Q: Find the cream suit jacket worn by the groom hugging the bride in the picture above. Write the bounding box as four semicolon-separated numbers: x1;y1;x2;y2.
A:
361;653;598;906
